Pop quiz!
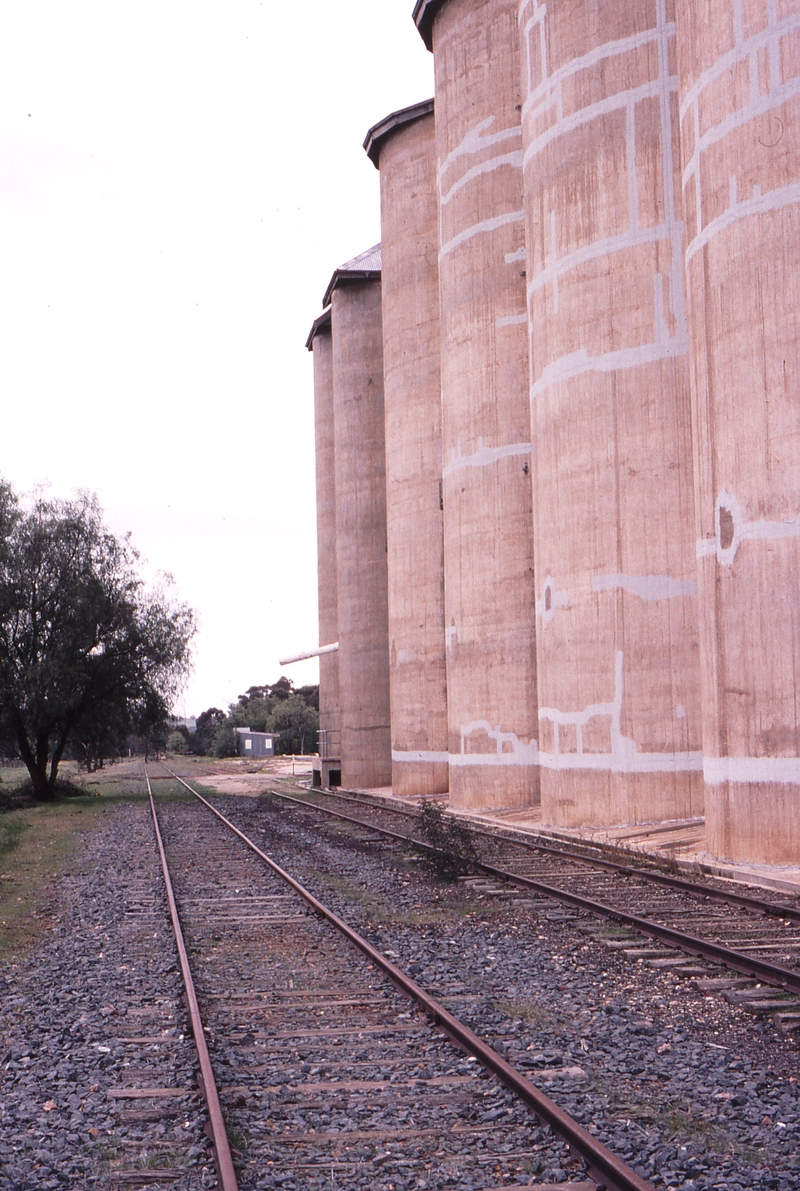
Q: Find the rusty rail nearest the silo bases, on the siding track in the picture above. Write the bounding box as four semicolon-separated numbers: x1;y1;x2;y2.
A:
279;790;800;923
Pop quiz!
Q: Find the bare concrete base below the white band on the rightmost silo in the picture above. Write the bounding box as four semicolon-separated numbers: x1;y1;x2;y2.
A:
706;781;800;865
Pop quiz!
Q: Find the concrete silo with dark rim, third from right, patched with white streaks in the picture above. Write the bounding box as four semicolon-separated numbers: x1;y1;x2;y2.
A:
414;0;538;807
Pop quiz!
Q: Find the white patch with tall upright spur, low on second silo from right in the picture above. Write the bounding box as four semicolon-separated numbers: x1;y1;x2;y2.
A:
539;649;702;773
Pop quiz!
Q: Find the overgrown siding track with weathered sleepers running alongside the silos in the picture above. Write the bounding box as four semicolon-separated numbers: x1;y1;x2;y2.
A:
253;787;800;1033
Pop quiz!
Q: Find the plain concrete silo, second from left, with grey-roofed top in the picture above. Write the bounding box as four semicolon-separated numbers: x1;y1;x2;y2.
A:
331;280;392;788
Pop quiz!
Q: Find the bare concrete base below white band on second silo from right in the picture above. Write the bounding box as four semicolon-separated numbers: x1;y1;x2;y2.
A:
540;768;704;828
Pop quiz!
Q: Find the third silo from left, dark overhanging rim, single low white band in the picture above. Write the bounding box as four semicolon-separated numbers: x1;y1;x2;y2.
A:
364;100;449;796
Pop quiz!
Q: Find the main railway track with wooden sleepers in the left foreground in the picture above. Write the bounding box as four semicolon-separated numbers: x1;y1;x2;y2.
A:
145;774;651;1191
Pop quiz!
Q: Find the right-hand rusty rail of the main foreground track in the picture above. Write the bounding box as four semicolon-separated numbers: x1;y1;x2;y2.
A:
160;762;655;1191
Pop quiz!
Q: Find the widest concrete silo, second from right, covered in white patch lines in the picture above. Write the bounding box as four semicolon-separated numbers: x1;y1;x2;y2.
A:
519;0;702;825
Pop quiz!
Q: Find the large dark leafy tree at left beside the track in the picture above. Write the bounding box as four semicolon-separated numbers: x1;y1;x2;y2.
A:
0;481;195;798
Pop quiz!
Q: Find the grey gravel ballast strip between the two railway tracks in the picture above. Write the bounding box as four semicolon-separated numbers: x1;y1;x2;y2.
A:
209;781;800;1191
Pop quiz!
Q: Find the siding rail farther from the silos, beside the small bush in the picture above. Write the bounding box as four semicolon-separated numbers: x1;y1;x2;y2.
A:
253;774;800;993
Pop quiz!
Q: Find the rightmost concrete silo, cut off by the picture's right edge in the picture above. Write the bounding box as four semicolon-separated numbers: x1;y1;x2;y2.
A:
676;0;800;863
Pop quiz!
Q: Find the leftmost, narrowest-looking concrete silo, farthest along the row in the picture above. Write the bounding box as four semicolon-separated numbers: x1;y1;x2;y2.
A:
312;322;340;756
